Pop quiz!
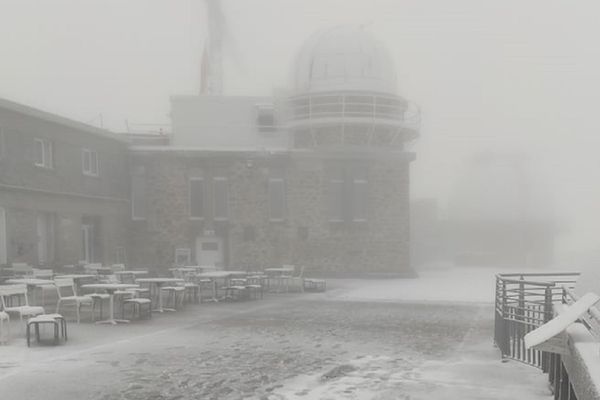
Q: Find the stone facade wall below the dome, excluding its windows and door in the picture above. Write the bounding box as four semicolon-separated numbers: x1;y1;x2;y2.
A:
129;150;412;274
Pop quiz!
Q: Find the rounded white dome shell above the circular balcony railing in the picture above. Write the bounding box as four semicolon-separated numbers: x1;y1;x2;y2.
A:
294;26;396;94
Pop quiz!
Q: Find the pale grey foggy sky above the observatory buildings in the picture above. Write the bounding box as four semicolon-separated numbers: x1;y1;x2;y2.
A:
0;0;600;260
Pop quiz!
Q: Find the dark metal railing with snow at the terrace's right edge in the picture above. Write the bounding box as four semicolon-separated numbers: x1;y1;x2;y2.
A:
494;273;600;400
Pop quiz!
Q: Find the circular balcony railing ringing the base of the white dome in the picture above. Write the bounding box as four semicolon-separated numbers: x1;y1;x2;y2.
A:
288;93;420;129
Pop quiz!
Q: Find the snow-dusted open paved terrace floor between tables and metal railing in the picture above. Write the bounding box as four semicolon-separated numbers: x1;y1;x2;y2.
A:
0;271;551;400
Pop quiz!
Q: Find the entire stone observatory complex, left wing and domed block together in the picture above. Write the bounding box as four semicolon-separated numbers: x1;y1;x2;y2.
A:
0;27;418;274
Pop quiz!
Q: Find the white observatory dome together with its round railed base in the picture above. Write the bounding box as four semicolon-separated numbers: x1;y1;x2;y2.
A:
288;26;419;150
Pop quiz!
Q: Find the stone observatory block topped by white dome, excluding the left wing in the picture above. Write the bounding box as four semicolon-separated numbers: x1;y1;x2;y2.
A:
130;27;418;274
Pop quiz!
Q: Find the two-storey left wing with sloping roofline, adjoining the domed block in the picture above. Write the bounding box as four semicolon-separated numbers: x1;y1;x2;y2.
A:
0;99;130;266
